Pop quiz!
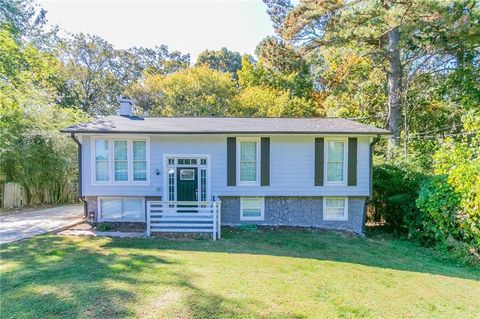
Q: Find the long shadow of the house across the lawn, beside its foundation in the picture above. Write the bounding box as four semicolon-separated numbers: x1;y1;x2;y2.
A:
105;228;480;280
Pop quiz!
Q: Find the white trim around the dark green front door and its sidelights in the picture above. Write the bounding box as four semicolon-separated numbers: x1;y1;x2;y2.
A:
162;154;212;201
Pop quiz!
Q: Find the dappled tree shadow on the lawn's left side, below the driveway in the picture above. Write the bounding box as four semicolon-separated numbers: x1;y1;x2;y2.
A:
0;237;168;318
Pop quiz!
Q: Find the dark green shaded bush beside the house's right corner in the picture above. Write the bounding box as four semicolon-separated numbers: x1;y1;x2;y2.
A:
368;163;425;232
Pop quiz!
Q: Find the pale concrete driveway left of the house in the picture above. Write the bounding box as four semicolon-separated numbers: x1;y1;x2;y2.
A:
0;205;83;244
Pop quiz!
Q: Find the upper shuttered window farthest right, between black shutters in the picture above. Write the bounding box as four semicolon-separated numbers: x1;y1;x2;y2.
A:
325;139;347;185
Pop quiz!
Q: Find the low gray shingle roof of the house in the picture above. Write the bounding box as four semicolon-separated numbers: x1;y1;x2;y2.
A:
61;116;389;134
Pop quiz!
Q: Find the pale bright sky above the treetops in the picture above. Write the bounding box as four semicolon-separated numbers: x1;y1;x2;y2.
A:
39;0;274;62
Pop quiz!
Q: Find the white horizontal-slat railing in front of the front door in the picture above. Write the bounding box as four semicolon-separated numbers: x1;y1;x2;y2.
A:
147;199;221;240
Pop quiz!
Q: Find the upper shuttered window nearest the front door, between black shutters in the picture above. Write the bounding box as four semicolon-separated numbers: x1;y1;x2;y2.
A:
237;138;260;185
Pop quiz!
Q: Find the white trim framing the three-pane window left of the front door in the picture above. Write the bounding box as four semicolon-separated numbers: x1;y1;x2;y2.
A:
90;136;150;186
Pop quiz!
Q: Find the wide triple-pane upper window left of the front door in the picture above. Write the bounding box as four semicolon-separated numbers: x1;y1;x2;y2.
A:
92;138;148;184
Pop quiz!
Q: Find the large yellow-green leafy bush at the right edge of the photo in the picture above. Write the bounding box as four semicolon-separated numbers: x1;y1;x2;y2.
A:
409;115;480;261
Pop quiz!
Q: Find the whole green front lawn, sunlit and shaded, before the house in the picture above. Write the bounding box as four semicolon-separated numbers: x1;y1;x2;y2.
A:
0;230;480;318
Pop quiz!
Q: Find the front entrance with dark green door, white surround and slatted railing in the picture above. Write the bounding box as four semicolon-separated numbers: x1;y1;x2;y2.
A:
146;154;221;240
